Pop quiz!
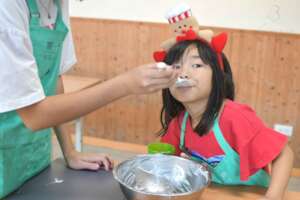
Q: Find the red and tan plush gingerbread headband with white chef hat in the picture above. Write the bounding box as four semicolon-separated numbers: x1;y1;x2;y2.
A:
153;4;227;69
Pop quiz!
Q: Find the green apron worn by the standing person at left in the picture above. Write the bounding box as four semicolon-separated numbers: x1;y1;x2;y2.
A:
0;0;68;198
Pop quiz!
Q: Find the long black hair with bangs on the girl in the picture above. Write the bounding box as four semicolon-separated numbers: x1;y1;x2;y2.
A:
159;40;234;136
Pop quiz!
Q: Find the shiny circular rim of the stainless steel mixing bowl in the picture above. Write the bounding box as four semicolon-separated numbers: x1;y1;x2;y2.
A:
112;153;211;197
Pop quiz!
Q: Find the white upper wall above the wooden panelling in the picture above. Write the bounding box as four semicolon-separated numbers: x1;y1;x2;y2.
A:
70;0;300;34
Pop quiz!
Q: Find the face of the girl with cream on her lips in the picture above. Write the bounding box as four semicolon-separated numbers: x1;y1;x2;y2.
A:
170;45;212;103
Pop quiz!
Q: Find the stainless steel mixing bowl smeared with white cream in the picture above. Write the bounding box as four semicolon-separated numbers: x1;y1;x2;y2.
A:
113;154;210;200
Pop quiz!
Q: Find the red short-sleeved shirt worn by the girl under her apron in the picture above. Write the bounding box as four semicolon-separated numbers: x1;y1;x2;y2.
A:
161;100;287;180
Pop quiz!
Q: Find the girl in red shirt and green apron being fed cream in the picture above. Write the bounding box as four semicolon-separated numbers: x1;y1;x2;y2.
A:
161;34;293;199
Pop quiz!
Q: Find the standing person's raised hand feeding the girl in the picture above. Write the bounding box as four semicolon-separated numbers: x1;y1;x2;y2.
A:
123;63;177;94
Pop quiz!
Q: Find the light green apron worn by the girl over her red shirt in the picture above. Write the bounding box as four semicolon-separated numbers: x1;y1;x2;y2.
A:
180;112;270;187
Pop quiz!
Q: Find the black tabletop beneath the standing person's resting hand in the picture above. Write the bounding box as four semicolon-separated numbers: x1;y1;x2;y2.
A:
5;159;125;200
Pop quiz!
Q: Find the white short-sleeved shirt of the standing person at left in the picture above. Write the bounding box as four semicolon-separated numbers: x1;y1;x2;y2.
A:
0;0;76;113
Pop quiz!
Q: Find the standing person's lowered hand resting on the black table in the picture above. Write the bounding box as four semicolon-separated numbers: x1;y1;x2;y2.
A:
65;151;114;171
